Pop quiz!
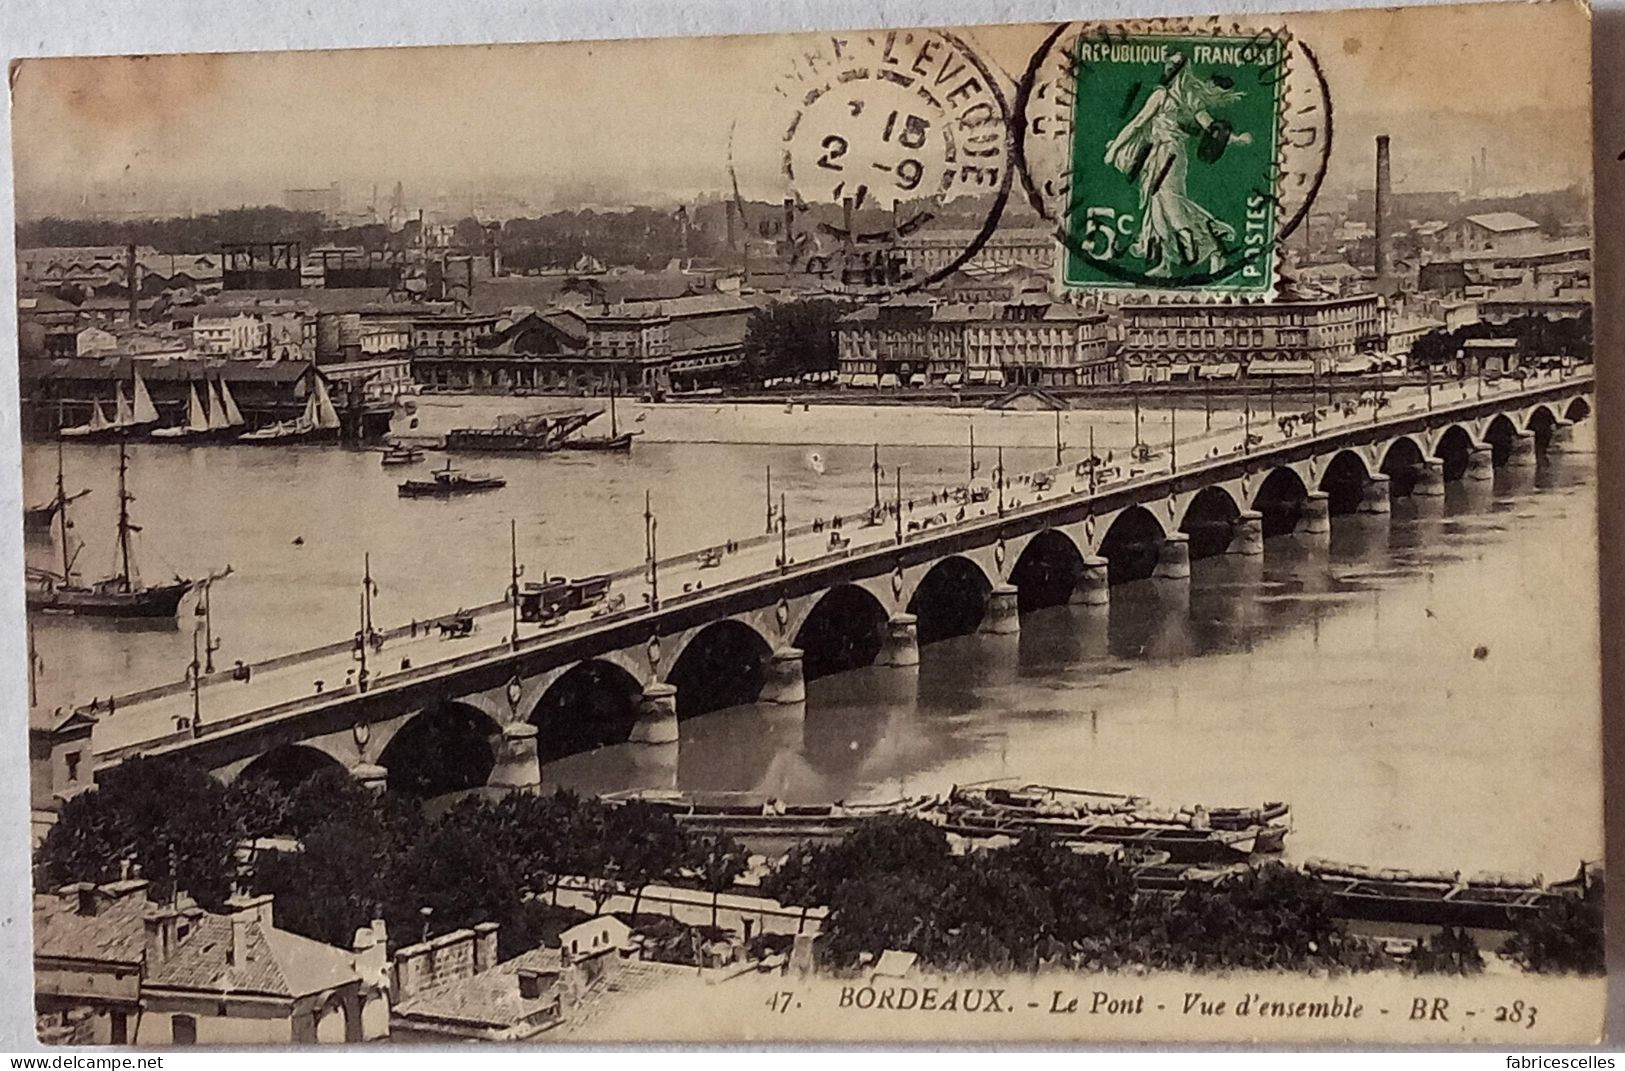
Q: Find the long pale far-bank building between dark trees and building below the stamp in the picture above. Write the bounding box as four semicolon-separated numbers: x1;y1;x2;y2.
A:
835;297;1116;387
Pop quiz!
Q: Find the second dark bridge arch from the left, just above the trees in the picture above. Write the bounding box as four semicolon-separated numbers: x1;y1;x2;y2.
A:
379;700;502;800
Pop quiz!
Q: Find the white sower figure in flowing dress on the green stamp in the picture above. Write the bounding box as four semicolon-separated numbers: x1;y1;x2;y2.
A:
1107;55;1253;278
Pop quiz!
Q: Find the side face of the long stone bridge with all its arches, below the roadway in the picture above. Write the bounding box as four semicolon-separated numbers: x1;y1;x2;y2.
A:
73;379;1591;796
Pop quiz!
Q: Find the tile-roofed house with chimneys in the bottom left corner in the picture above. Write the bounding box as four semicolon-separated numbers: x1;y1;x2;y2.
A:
34;878;388;1045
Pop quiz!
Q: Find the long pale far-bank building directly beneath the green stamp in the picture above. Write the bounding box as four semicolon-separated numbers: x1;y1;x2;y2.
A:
1121;294;1386;382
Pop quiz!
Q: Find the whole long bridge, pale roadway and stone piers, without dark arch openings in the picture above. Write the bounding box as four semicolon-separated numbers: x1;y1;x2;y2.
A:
52;369;1591;783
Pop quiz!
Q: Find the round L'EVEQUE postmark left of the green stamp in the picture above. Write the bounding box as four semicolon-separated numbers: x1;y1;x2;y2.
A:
741;29;1016;296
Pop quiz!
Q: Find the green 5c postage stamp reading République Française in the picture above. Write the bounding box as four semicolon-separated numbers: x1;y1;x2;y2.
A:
1063;34;1285;294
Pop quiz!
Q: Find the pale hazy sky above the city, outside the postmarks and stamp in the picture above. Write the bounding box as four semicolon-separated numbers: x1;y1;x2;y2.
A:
13;0;1591;218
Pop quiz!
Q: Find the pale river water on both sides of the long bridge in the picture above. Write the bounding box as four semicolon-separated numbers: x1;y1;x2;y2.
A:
24;403;1602;878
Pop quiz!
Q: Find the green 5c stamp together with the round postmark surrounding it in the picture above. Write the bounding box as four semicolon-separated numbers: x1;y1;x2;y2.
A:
1016;20;1333;297
